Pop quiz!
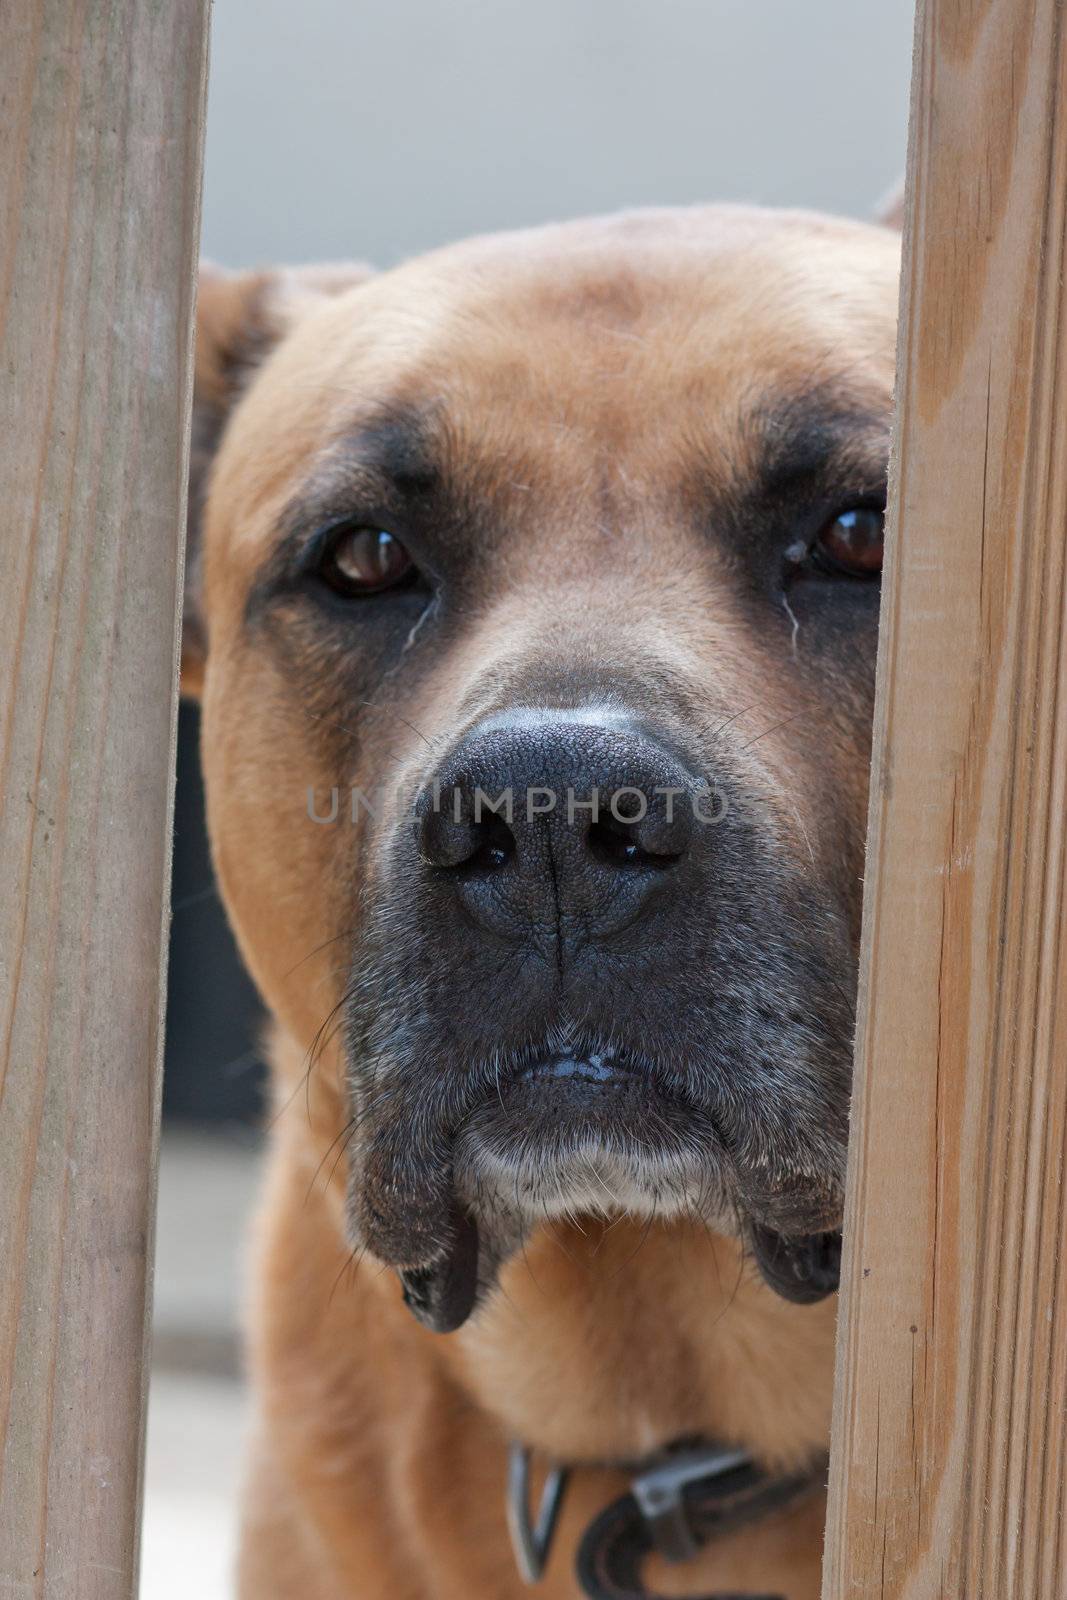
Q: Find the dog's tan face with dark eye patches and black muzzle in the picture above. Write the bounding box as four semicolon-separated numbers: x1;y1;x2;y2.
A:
191;208;899;1326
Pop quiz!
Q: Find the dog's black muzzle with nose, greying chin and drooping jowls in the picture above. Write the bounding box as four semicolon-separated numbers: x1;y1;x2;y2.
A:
347;707;851;1331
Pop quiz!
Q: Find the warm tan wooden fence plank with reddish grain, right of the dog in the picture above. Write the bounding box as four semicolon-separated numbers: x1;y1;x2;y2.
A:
824;0;1067;1600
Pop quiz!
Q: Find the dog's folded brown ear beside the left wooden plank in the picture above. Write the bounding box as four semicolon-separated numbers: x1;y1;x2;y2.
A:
181;262;371;698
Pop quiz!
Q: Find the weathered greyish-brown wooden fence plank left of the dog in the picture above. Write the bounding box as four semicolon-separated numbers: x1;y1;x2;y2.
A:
0;0;208;1600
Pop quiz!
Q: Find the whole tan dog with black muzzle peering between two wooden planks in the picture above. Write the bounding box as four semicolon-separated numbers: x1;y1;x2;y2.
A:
184;208;897;1600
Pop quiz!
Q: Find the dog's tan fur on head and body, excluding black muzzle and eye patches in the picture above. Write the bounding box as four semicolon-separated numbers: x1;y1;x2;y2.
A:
192;208;897;1600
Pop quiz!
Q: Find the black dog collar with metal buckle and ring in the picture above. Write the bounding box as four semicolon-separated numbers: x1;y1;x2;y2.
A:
507;1440;825;1600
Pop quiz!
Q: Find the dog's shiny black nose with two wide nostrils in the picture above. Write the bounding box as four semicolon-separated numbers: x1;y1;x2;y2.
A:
416;712;701;944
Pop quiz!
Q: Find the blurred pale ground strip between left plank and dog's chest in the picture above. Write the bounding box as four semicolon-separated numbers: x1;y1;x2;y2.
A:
141;1131;259;1600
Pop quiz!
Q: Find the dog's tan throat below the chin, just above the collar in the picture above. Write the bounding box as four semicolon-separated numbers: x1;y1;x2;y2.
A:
448;1218;833;1466
